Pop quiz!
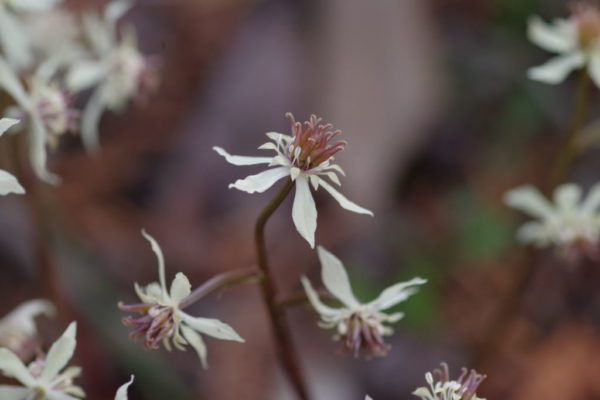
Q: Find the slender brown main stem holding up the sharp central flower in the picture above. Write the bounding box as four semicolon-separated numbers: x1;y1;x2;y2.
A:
254;178;309;400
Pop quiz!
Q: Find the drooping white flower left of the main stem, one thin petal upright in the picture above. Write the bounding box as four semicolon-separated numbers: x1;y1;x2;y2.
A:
119;231;244;368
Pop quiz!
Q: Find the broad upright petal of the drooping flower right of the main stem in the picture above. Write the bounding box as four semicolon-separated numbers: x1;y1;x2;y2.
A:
317;246;360;308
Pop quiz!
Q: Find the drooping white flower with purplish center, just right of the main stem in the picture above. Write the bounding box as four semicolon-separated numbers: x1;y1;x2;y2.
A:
301;246;427;357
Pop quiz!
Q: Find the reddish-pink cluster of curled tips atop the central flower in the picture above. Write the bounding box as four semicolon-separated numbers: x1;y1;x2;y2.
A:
286;113;346;171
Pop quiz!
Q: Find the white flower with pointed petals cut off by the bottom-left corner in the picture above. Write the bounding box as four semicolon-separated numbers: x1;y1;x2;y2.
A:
0;322;85;400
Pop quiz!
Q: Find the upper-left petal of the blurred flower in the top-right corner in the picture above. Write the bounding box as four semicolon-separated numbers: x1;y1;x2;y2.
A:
527;15;577;53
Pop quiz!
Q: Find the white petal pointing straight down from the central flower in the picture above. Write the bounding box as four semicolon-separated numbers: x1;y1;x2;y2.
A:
292;175;317;248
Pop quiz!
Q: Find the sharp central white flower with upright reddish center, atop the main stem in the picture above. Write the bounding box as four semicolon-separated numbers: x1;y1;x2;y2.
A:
213;113;373;247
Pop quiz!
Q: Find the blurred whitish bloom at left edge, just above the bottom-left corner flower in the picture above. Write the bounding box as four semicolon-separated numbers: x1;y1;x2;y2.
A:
0;299;56;359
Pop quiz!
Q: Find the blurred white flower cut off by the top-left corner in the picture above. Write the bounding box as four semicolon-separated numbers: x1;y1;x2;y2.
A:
0;0;62;68
